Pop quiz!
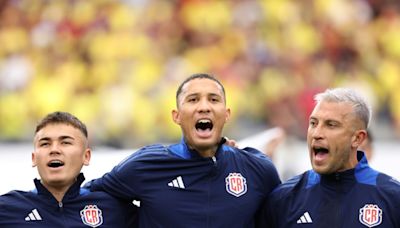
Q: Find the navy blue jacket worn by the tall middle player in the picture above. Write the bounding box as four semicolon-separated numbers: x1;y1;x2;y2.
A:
91;142;280;228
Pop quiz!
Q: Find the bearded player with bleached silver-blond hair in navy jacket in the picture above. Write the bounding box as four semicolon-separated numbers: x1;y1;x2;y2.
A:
261;88;400;228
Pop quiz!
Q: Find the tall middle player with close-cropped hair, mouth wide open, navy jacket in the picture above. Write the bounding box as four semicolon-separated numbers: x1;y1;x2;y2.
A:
90;74;280;228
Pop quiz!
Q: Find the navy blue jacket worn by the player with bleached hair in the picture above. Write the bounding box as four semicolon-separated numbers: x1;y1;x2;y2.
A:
261;151;400;228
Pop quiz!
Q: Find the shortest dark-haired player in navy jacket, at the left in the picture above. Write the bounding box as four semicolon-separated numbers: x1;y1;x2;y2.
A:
0;112;136;228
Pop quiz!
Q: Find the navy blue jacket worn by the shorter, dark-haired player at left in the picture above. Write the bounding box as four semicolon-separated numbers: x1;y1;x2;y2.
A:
0;174;137;228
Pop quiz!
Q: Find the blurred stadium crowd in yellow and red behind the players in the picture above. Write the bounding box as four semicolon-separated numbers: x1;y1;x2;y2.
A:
0;0;400;147
